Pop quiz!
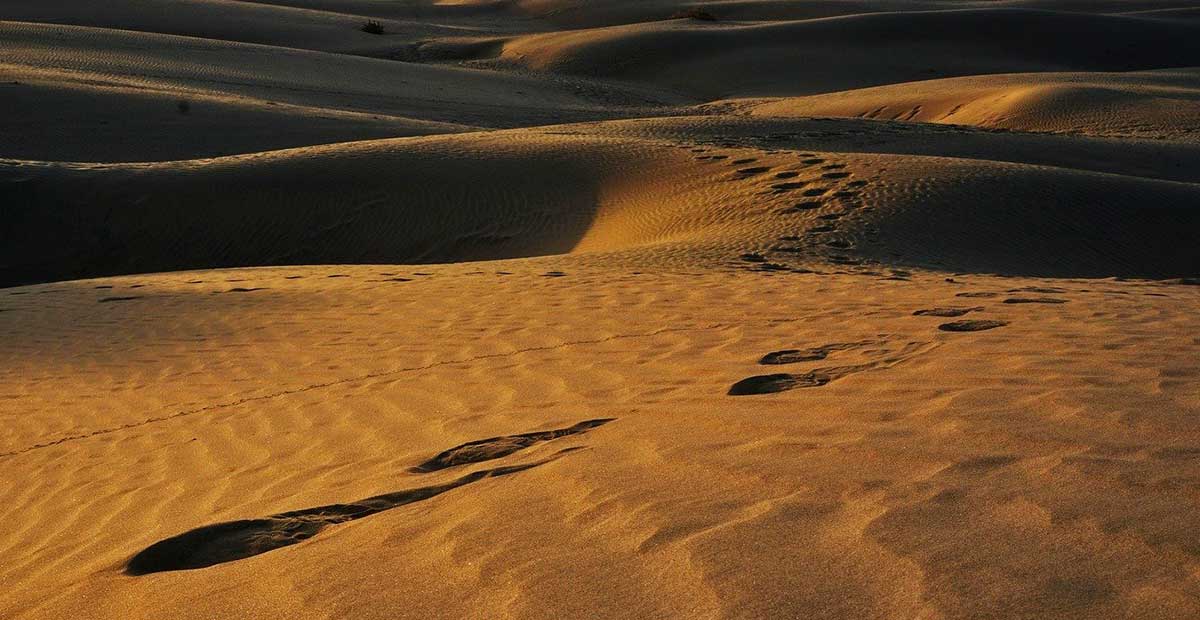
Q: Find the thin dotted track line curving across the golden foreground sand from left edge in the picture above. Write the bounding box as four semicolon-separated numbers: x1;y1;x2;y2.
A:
0;319;748;458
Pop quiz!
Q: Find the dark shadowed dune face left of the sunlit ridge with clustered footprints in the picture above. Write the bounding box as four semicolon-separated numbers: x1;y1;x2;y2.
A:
0;134;682;282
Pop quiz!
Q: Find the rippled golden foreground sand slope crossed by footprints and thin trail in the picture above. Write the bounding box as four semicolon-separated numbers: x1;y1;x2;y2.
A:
0;266;1200;619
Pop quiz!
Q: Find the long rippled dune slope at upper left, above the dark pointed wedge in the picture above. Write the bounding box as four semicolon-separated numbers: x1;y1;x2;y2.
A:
0;22;657;126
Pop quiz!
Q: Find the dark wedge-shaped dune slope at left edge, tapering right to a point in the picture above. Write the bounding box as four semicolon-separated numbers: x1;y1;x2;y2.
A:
0;66;470;162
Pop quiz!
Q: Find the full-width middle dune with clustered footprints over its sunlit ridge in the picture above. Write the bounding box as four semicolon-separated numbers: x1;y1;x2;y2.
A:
0;121;1200;283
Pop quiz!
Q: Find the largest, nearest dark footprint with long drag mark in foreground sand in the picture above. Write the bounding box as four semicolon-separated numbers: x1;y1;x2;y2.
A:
125;451;566;576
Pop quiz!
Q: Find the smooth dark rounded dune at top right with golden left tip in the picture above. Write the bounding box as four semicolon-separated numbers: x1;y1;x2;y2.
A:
502;8;1200;98
